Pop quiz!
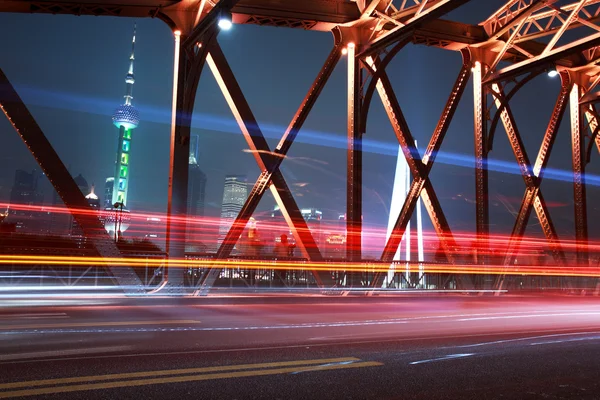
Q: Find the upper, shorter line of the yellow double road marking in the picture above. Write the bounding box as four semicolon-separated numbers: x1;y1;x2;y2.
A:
0;357;360;390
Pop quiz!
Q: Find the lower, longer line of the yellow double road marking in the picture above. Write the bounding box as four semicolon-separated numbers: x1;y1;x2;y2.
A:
0;361;383;399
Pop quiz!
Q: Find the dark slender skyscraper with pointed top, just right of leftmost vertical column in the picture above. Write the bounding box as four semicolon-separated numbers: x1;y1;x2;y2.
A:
187;135;206;251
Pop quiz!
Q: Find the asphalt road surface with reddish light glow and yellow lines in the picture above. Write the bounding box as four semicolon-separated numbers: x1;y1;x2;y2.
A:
0;296;600;399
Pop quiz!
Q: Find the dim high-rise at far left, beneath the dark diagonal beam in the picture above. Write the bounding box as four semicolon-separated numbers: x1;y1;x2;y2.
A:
9;169;44;231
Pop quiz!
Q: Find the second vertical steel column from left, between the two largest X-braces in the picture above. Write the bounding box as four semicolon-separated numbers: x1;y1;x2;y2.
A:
346;43;362;261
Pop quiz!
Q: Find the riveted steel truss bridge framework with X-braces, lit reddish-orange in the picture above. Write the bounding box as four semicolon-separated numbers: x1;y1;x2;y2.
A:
0;0;600;294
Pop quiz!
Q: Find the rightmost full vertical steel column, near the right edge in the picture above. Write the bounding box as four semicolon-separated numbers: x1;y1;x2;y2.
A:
569;83;588;265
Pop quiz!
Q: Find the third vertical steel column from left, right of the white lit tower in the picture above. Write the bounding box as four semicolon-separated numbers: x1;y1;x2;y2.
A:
473;61;490;272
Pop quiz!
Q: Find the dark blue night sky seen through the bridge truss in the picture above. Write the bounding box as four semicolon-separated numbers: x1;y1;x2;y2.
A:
0;0;600;255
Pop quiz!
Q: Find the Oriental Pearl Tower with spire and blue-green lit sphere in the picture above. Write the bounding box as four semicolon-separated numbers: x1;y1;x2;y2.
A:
104;25;140;236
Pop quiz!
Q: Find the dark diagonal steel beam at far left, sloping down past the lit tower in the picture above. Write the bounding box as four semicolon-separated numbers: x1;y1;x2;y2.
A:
0;69;144;295
